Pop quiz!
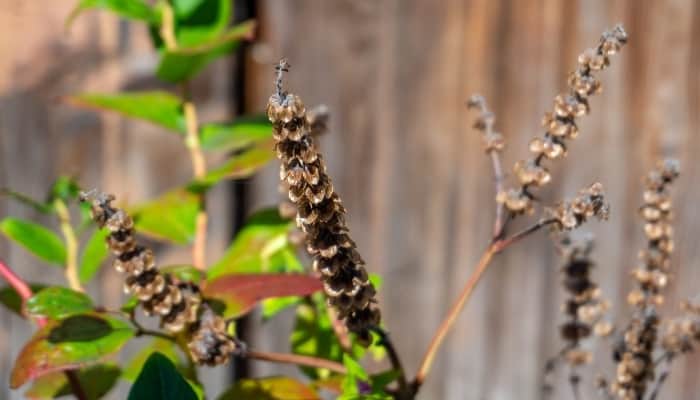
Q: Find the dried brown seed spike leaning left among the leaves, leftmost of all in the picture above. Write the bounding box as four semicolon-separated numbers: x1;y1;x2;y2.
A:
81;192;237;365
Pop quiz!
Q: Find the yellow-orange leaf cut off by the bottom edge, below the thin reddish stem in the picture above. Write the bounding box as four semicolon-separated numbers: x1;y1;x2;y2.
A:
218;376;321;400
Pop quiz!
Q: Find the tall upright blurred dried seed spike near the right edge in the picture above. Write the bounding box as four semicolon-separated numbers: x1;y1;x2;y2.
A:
611;160;683;400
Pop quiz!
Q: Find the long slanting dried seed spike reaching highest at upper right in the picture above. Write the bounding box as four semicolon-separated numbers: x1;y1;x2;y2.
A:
496;26;627;215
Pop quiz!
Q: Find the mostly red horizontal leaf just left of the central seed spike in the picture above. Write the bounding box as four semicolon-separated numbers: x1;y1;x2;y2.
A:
204;274;321;318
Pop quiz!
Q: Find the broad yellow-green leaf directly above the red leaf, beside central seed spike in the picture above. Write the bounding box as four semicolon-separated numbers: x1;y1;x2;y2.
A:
208;208;303;279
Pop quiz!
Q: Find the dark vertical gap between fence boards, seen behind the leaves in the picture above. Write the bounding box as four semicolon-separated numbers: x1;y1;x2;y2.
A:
230;0;256;381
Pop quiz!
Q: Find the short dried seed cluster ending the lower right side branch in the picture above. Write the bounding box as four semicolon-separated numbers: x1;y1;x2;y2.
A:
545;182;610;231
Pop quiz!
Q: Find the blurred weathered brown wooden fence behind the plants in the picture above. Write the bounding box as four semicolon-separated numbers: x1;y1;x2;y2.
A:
0;0;700;400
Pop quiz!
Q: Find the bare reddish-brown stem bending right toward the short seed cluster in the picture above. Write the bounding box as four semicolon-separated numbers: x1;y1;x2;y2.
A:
413;219;556;391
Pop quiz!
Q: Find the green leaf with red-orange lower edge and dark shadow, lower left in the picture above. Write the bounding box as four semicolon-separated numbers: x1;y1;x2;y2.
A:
10;313;134;389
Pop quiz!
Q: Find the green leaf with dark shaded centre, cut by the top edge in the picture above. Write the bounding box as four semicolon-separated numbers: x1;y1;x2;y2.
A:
172;0;231;47
